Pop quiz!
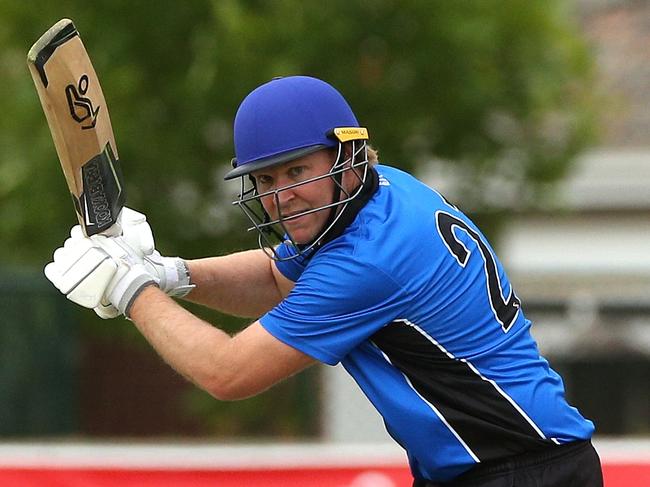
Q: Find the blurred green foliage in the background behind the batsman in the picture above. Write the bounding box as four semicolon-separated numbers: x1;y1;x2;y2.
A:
0;0;596;440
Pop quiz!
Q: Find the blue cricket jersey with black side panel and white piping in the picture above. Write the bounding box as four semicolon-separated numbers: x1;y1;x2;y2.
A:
260;165;594;481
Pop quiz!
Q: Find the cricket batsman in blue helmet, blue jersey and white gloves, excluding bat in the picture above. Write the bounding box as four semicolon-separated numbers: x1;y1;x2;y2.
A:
45;76;602;487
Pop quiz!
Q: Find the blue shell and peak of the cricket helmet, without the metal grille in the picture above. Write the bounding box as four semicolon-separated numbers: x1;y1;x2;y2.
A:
225;76;359;179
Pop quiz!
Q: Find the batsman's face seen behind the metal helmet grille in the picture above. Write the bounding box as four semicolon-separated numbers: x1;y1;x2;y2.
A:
252;150;335;244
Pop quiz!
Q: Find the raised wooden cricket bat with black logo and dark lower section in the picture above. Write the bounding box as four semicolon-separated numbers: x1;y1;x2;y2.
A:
27;19;125;236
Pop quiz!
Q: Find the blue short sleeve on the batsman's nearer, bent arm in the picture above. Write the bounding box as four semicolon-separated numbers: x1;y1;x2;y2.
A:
260;254;407;365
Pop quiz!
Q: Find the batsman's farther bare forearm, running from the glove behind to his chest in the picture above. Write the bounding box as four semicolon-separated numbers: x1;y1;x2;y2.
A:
186;250;282;318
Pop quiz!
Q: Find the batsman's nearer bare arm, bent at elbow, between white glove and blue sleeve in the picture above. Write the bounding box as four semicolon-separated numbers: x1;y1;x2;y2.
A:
130;286;314;400
